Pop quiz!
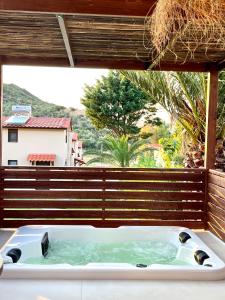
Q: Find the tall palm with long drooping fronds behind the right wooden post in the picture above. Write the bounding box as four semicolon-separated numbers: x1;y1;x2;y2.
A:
121;71;225;167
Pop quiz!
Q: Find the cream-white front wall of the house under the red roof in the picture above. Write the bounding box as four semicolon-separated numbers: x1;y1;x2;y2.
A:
2;128;71;166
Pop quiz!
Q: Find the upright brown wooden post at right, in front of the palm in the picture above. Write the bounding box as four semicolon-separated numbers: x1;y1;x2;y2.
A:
205;68;219;169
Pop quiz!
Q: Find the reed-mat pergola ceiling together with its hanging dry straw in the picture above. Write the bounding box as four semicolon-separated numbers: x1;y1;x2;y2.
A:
0;0;225;71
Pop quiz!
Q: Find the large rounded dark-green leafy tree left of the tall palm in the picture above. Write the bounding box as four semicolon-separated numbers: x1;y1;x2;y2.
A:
82;71;160;136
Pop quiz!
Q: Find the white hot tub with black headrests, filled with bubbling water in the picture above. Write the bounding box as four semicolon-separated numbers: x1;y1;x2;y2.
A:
1;226;225;280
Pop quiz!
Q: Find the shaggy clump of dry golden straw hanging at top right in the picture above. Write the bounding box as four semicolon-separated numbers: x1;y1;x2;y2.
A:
146;0;225;68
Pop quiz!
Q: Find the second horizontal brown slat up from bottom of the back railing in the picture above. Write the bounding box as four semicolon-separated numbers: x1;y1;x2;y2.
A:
4;210;204;220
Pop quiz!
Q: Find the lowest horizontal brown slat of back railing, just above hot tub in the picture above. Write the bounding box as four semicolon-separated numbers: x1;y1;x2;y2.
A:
3;220;204;229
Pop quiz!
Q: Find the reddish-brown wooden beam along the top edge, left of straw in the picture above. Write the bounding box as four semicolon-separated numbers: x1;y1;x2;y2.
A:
0;0;157;17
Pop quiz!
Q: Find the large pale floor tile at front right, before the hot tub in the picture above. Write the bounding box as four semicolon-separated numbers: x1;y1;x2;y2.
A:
82;281;225;300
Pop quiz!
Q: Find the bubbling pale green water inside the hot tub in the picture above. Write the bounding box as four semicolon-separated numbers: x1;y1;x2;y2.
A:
23;240;185;265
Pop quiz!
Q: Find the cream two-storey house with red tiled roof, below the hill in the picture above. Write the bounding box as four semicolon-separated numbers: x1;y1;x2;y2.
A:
2;115;84;167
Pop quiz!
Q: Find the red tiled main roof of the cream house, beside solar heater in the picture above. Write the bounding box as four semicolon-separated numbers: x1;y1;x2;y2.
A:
2;117;71;129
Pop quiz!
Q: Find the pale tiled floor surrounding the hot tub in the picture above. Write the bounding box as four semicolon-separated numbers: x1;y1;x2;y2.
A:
0;231;225;300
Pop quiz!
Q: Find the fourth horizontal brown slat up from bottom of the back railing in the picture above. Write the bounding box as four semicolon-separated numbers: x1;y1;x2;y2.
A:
0;190;204;201
